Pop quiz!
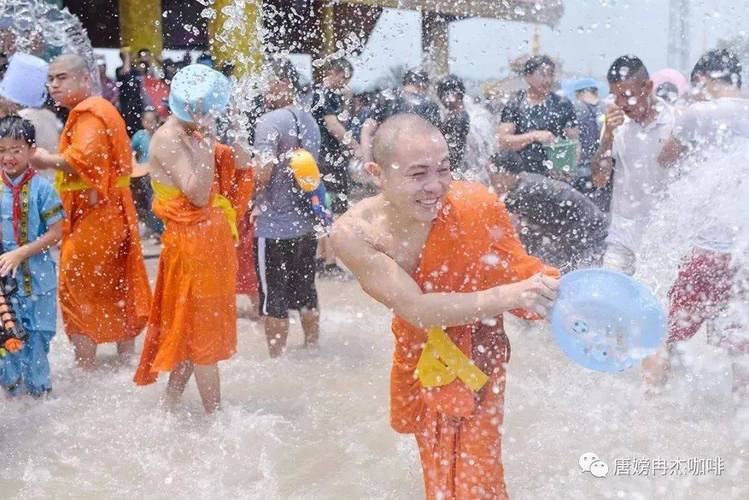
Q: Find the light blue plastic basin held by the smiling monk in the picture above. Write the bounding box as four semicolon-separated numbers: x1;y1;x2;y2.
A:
551;269;666;372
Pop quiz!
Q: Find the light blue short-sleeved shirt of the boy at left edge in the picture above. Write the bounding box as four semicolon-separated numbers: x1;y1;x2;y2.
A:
0;175;64;297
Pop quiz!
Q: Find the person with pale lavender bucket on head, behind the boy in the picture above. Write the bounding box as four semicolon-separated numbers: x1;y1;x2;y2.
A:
0;52;62;151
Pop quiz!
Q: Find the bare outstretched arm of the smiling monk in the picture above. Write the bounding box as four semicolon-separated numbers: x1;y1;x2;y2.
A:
331;221;551;328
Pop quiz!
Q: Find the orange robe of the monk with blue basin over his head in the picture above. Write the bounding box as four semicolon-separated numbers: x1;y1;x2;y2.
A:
134;145;253;385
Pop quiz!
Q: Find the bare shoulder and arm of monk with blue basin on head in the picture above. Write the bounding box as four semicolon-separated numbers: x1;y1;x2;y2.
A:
149;135;215;207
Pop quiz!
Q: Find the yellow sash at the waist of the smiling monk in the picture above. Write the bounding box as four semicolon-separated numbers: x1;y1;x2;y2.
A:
415;328;489;392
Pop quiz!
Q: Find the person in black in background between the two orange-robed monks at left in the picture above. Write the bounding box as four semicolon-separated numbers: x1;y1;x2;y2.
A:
116;47;150;137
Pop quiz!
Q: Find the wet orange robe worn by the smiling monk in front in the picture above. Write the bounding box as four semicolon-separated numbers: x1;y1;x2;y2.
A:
390;182;558;500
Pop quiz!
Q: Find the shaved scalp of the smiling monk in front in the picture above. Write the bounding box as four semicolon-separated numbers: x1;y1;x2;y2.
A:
372;113;444;167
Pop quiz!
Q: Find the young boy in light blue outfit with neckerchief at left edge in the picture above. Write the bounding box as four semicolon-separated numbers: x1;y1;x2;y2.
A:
0;115;63;396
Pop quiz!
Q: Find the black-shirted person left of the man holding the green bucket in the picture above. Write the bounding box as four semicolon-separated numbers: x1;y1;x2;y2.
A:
437;75;471;172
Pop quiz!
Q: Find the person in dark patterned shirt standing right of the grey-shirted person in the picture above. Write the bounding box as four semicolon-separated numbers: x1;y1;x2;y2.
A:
312;58;361;214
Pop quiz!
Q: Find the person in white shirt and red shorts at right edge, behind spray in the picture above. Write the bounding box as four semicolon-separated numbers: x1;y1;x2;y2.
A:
643;49;749;410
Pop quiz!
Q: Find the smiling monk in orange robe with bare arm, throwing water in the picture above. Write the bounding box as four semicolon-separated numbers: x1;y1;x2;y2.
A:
331;114;558;499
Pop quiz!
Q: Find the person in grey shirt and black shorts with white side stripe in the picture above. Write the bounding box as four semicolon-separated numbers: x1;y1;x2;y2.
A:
253;59;320;357
